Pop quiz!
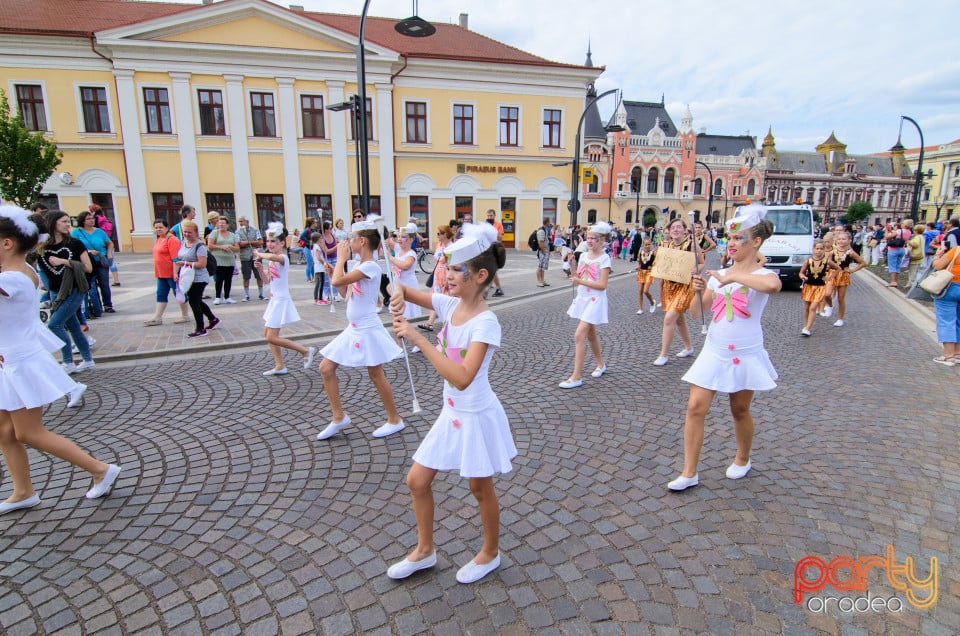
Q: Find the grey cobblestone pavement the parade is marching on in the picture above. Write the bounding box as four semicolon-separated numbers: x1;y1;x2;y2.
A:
0;252;960;635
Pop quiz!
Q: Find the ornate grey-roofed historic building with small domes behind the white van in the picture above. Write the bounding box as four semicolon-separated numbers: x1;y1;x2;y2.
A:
761;129;914;223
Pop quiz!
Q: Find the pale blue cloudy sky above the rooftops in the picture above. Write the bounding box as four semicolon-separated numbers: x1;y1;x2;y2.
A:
266;0;960;154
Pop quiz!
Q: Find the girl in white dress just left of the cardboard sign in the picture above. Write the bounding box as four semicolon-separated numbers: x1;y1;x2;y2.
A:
560;222;612;389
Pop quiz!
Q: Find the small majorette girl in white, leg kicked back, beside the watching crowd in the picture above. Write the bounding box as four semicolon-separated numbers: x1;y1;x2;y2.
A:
253;223;317;376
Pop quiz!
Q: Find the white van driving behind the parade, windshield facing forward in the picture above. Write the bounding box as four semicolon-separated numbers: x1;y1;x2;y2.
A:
760;204;814;286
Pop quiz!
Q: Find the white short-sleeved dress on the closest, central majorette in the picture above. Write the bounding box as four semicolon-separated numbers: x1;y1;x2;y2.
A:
413;294;517;477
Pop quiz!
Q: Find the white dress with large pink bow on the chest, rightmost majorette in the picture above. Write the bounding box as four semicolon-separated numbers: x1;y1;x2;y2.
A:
683;268;777;393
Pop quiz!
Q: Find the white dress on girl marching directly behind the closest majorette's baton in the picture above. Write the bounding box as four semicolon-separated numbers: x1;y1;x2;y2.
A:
320;261;403;367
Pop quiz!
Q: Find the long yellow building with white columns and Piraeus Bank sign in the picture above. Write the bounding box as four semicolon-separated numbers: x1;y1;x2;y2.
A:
0;0;603;251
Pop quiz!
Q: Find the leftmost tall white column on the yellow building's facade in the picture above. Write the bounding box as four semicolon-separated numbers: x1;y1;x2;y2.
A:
113;70;153;243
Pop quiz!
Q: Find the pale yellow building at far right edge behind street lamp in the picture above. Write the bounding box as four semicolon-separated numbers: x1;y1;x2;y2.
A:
904;139;960;222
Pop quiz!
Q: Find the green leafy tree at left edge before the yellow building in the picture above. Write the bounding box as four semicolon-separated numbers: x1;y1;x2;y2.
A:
0;89;63;208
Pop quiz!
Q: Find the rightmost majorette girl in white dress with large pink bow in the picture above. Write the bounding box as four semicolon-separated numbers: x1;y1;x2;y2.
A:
667;204;780;490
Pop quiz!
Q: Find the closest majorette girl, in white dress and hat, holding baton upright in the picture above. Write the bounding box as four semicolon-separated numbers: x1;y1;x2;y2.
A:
387;223;517;583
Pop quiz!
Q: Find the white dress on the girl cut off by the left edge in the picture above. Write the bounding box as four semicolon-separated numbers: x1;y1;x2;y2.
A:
0;271;77;411
